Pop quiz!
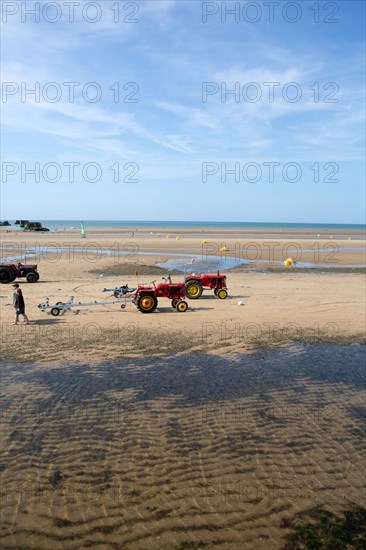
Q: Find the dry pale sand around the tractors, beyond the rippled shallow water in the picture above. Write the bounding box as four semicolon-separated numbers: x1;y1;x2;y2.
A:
0;227;366;361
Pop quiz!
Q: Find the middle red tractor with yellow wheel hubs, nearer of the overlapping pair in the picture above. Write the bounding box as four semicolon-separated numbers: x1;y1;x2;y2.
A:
132;277;188;313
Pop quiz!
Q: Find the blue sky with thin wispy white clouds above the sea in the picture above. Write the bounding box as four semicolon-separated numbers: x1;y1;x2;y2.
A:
0;0;365;223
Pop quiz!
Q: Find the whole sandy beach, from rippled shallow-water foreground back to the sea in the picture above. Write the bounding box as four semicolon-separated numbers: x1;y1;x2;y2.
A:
0;227;366;550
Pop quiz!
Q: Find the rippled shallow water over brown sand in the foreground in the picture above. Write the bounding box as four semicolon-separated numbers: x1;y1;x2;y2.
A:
1;344;366;550
